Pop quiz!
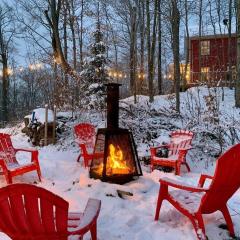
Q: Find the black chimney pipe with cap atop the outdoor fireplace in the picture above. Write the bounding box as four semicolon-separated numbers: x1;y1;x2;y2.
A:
105;83;122;129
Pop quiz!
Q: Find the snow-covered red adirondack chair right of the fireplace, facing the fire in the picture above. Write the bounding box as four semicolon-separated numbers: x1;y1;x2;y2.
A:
150;130;193;175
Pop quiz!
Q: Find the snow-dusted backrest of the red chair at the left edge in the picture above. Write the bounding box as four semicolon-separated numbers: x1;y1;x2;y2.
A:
0;133;17;163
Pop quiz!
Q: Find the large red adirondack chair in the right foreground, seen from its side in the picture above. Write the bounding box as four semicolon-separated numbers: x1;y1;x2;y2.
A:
155;144;240;240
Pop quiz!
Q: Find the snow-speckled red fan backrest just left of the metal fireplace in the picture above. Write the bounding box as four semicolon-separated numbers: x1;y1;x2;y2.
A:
74;123;96;148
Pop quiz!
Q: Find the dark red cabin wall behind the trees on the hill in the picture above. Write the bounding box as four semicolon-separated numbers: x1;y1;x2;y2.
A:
190;36;237;84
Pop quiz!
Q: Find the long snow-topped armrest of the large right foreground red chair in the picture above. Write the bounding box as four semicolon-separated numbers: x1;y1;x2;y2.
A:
159;178;208;192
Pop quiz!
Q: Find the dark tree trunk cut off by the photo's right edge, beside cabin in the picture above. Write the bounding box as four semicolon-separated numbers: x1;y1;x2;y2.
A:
235;0;240;108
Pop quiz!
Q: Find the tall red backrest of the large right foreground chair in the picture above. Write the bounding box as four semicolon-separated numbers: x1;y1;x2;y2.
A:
200;144;240;213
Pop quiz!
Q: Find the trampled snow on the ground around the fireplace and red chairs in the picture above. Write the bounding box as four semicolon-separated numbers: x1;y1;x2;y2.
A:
0;87;240;240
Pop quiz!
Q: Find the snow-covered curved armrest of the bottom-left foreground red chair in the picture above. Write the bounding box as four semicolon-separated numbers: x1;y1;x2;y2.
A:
68;198;101;235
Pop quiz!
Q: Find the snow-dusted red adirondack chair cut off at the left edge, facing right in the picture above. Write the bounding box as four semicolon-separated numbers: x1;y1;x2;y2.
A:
0;133;41;184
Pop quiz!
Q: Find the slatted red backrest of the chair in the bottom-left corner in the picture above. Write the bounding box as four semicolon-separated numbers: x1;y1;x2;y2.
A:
0;184;69;240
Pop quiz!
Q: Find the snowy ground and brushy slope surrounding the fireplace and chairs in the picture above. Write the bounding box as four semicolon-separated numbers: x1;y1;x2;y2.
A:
0;87;240;240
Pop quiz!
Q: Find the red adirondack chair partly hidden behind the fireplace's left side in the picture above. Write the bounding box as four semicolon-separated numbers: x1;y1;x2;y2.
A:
74;123;103;168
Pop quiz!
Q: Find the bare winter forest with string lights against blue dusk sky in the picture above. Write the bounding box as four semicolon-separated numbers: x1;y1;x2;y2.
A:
0;0;237;123
